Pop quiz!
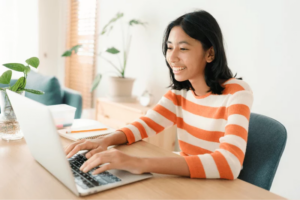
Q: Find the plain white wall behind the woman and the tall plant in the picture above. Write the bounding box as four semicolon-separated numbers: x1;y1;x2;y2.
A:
97;0;300;199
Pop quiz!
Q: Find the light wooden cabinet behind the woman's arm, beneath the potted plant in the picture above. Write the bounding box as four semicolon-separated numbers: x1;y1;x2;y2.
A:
96;98;176;151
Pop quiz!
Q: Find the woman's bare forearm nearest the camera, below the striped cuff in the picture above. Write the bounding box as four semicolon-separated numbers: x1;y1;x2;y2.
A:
137;157;190;176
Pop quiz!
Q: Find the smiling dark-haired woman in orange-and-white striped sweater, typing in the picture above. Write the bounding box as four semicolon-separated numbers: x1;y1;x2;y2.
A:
66;11;253;179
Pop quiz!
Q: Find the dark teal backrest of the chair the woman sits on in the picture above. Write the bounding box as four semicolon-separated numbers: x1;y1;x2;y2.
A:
238;113;287;190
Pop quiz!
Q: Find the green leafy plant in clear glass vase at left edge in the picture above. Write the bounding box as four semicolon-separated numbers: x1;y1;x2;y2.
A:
0;57;44;140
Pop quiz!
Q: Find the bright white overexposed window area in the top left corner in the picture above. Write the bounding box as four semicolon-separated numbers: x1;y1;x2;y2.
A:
0;0;38;78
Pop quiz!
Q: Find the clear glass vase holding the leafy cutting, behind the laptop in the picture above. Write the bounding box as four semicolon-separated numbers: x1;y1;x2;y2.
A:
0;90;25;141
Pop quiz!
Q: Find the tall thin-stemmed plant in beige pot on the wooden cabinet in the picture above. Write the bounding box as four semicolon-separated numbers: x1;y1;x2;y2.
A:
62;13;146;102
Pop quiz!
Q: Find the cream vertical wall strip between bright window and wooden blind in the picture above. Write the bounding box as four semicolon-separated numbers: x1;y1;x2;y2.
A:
38;0;68;85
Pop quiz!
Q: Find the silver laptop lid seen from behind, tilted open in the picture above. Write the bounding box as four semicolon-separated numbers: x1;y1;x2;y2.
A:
6;90;79;196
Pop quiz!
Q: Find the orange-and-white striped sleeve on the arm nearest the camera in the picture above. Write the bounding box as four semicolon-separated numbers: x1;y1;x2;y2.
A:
185;90;253;179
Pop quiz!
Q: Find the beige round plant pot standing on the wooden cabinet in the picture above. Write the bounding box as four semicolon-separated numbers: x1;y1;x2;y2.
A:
108;76;136;102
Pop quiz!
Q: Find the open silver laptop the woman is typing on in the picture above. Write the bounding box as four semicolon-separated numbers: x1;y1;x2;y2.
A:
6;90;153;196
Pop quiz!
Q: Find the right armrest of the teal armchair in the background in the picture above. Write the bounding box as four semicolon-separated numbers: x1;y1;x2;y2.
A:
62;88;82;119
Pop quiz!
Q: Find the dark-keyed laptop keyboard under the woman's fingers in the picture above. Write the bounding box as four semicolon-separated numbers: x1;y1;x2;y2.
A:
69;154;121;189
